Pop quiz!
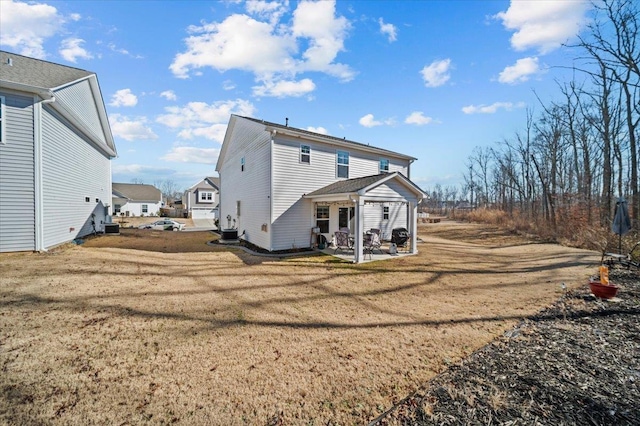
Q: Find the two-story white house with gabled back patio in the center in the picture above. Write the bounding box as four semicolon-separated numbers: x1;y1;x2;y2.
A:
216;115;426;262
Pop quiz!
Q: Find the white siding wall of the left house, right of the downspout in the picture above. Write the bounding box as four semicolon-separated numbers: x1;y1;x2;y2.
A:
42;107;111;247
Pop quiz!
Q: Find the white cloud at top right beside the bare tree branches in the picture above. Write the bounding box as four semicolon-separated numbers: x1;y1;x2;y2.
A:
495;0;591;54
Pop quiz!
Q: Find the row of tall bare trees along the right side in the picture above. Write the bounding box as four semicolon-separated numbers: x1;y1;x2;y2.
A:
422;0;640;248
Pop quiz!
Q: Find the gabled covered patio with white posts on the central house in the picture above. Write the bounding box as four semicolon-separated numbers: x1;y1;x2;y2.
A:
303;172;426;263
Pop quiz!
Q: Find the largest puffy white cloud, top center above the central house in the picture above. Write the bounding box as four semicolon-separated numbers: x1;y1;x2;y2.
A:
169;1;355;96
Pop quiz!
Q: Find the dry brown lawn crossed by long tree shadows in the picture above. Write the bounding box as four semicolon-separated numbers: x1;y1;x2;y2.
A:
0;222;599;425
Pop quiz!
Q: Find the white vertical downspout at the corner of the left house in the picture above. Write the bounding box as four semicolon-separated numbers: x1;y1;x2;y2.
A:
33;91;56;252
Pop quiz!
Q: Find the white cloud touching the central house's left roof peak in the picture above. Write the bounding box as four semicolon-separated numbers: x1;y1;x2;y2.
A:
156;99;255;143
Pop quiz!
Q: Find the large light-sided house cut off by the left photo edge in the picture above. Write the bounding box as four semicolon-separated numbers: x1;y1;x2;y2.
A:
0;51;116;252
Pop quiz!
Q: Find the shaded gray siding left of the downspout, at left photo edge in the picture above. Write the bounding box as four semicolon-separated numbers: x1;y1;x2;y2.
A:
0;93;36;252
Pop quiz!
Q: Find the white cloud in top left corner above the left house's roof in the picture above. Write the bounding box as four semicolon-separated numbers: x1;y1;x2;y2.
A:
0;0;65;58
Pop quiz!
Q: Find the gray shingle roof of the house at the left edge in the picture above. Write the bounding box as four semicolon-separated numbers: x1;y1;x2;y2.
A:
0;51;95;89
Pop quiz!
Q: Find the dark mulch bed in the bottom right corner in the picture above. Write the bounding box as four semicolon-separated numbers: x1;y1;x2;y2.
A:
371;269;640;425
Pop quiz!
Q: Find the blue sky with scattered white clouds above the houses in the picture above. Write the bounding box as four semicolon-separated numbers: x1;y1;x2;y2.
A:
0;0;589;189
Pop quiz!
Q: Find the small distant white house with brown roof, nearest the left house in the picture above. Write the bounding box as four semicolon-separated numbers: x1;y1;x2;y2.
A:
112;182;162;216
